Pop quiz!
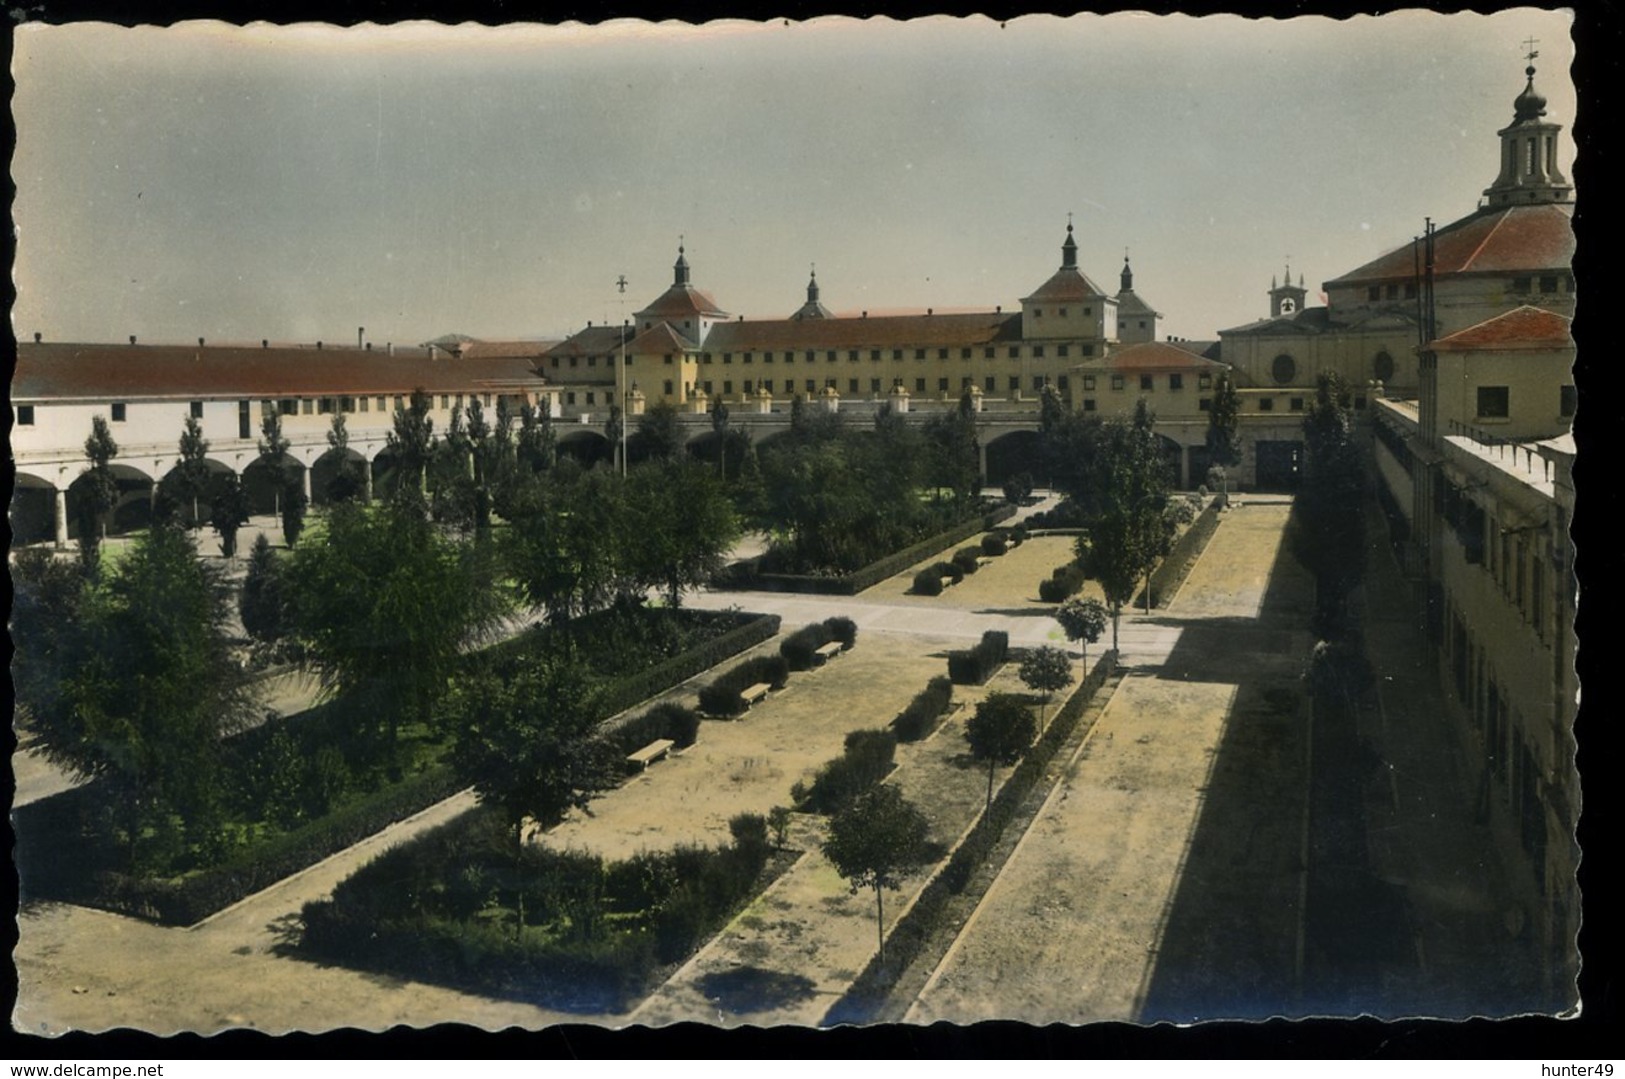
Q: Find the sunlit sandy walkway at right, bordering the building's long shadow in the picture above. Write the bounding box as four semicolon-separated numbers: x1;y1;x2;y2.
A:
907;505;1302;1024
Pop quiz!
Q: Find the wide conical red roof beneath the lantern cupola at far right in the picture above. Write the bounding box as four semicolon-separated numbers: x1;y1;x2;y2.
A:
1326;203;1575;288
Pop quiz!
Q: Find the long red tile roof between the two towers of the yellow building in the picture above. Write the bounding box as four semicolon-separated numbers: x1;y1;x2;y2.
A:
705;312;1021;349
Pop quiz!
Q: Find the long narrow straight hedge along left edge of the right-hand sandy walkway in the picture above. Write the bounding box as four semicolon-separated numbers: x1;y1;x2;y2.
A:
819;652;1116;1027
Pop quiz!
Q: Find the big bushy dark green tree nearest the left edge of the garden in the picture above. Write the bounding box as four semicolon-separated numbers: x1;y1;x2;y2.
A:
18;527;254;868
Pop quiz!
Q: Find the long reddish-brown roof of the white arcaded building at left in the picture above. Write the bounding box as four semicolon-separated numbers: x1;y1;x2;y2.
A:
11;345;544;400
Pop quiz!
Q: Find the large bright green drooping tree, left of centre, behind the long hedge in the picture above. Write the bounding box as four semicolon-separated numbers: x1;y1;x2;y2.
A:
284;501;502;746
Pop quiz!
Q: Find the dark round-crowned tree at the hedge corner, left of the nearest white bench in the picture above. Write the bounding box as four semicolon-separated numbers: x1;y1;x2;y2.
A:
445;663;621;855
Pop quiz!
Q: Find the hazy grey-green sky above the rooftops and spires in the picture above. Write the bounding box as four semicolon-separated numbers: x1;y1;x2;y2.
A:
11;8;1576;343
